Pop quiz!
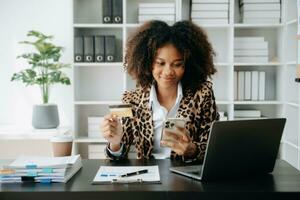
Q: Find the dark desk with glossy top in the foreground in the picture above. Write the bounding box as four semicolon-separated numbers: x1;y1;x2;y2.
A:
0;160;300;200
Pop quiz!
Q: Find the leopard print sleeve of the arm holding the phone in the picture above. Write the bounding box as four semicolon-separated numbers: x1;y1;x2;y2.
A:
171;82;219;162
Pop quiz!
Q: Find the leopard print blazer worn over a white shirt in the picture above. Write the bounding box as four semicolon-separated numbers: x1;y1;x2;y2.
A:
106;81;219;162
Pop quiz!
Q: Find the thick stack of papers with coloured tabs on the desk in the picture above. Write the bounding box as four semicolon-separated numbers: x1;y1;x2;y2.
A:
0;155;82;183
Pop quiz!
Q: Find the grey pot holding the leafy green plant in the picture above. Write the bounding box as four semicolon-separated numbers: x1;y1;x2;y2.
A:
32;104;59;129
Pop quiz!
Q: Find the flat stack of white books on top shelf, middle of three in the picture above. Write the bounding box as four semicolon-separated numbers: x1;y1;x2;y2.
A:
191;0;229;25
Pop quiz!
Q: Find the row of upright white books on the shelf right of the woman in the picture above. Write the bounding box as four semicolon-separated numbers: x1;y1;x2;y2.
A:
234;71;266;101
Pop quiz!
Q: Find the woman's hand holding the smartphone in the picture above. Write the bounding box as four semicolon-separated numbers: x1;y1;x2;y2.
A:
161;127;197;157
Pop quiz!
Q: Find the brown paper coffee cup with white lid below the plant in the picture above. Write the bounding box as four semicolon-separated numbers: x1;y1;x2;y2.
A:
51;135;73;157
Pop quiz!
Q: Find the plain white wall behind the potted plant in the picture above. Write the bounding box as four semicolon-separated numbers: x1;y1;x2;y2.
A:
0;0;73;126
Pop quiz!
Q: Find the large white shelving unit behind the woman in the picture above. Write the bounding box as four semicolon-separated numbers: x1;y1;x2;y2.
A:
73;0;300;165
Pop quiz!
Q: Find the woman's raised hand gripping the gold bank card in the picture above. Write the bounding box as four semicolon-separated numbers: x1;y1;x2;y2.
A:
100;114;123;151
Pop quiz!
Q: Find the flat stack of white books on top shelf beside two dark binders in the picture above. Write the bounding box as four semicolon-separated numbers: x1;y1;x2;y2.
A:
138;3;175;24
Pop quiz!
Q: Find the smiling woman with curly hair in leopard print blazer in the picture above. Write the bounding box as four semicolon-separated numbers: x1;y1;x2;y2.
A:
101;21;219;161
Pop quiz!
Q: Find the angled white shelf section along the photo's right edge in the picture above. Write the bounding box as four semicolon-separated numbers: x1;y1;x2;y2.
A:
282;0;300;170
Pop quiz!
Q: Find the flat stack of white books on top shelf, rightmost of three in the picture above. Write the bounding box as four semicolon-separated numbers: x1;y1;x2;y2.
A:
240;0;281;24
